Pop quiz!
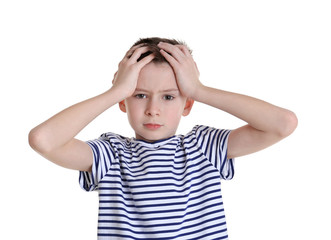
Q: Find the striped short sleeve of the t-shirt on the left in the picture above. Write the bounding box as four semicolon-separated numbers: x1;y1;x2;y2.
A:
79;137;115;191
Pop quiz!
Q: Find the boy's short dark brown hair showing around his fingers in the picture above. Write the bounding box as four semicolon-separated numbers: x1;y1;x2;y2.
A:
132;37;192;63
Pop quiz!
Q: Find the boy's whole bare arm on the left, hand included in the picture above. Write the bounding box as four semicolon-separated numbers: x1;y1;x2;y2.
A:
29;45;154;171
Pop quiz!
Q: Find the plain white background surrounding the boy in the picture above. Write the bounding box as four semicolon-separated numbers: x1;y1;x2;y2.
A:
0;0;331;240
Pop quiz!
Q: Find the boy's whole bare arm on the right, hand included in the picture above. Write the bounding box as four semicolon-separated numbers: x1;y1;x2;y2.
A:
159;43;297;158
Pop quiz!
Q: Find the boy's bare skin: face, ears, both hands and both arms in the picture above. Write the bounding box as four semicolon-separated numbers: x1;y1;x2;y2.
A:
29;43;297;171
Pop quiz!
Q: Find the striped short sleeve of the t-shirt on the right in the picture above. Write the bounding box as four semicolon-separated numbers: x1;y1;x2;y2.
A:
193;126;234;180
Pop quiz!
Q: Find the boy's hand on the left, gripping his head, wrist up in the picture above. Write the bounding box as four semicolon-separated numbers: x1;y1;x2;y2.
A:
112;44;154;98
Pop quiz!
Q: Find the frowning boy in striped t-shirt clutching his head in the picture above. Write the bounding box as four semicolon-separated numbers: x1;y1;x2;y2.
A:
29;38;297;240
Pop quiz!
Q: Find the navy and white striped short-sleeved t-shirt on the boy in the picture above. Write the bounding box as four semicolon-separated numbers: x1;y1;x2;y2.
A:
80;126;234;240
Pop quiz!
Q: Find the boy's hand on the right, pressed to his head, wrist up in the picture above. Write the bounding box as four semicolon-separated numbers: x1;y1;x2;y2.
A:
158;42;202;99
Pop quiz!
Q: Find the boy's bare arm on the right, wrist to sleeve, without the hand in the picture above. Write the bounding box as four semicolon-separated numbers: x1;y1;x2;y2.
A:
195;86;297;158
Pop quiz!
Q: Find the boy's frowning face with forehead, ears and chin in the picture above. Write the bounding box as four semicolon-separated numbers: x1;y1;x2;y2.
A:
120;63;193;142
